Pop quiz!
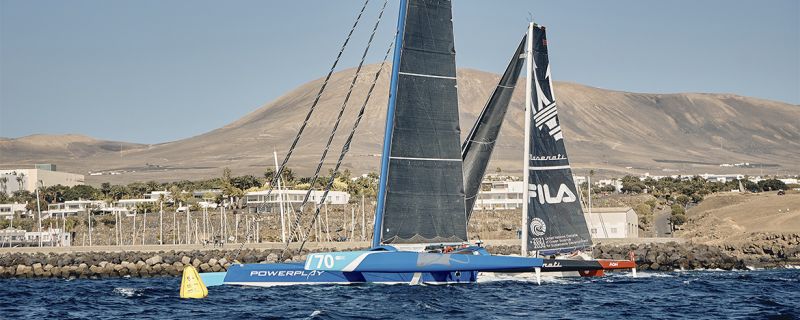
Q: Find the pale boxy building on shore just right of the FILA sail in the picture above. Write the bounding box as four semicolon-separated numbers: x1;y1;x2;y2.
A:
583;207;639;239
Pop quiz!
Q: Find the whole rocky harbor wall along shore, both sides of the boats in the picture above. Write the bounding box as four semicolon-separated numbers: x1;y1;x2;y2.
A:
0;234;800;279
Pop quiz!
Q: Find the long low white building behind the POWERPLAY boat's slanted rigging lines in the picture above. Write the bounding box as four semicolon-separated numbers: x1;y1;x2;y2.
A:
245;190;350;213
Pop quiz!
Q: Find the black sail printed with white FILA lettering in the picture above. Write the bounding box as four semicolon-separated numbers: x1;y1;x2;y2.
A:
525;25;591;254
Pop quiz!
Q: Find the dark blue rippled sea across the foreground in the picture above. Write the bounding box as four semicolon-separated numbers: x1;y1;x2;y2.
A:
0;269;800;320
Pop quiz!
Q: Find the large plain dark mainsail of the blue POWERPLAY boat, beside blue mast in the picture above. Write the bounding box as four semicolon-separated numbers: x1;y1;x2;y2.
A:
377;0;467;243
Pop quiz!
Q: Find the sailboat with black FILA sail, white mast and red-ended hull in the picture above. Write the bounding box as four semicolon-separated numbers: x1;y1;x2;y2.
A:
521;22;636;276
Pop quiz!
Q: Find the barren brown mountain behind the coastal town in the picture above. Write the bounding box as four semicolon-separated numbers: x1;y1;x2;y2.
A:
0;65;800;184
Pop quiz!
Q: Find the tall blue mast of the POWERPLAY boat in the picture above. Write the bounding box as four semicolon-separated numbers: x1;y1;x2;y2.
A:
372;0;408;248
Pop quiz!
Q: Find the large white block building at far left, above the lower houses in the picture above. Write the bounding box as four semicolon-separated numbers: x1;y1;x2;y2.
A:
0;164;84;194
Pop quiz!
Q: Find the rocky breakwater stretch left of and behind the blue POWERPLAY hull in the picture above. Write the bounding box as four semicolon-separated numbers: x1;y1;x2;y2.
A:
0;249;300;279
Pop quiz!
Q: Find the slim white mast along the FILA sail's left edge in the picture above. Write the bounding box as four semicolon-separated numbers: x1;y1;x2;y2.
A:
520;22;534;257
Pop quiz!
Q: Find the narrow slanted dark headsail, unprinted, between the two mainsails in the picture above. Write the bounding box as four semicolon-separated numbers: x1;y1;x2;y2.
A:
461;36;527;221
